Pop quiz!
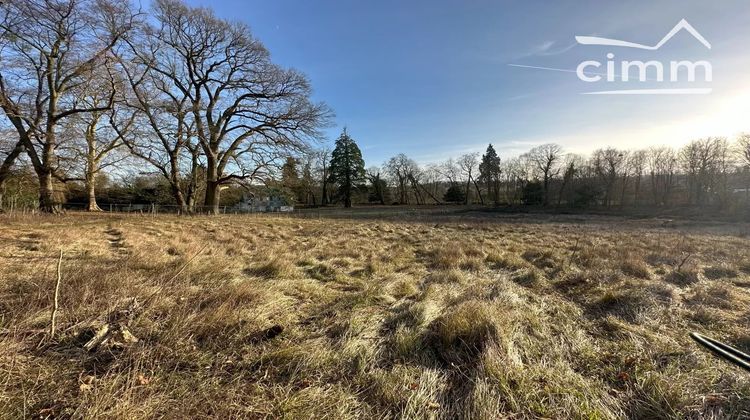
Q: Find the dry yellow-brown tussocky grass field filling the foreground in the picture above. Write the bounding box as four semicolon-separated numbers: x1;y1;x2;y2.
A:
0;214;750;419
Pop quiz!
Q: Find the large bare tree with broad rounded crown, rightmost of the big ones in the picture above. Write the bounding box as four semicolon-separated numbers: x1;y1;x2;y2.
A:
125;0;330;213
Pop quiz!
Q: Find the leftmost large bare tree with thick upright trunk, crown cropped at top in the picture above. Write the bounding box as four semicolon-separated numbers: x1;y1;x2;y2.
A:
0;0;133;212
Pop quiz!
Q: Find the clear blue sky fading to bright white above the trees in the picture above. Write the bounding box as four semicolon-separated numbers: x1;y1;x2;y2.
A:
178;0;750;166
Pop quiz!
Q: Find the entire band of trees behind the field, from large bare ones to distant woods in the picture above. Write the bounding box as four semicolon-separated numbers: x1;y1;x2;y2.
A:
0;0;750;213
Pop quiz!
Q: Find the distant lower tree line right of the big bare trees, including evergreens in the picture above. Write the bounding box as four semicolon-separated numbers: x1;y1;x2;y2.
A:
302;132;750;210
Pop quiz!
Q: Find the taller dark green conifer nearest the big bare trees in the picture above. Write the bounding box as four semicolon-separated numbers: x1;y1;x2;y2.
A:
329;128;365;207
